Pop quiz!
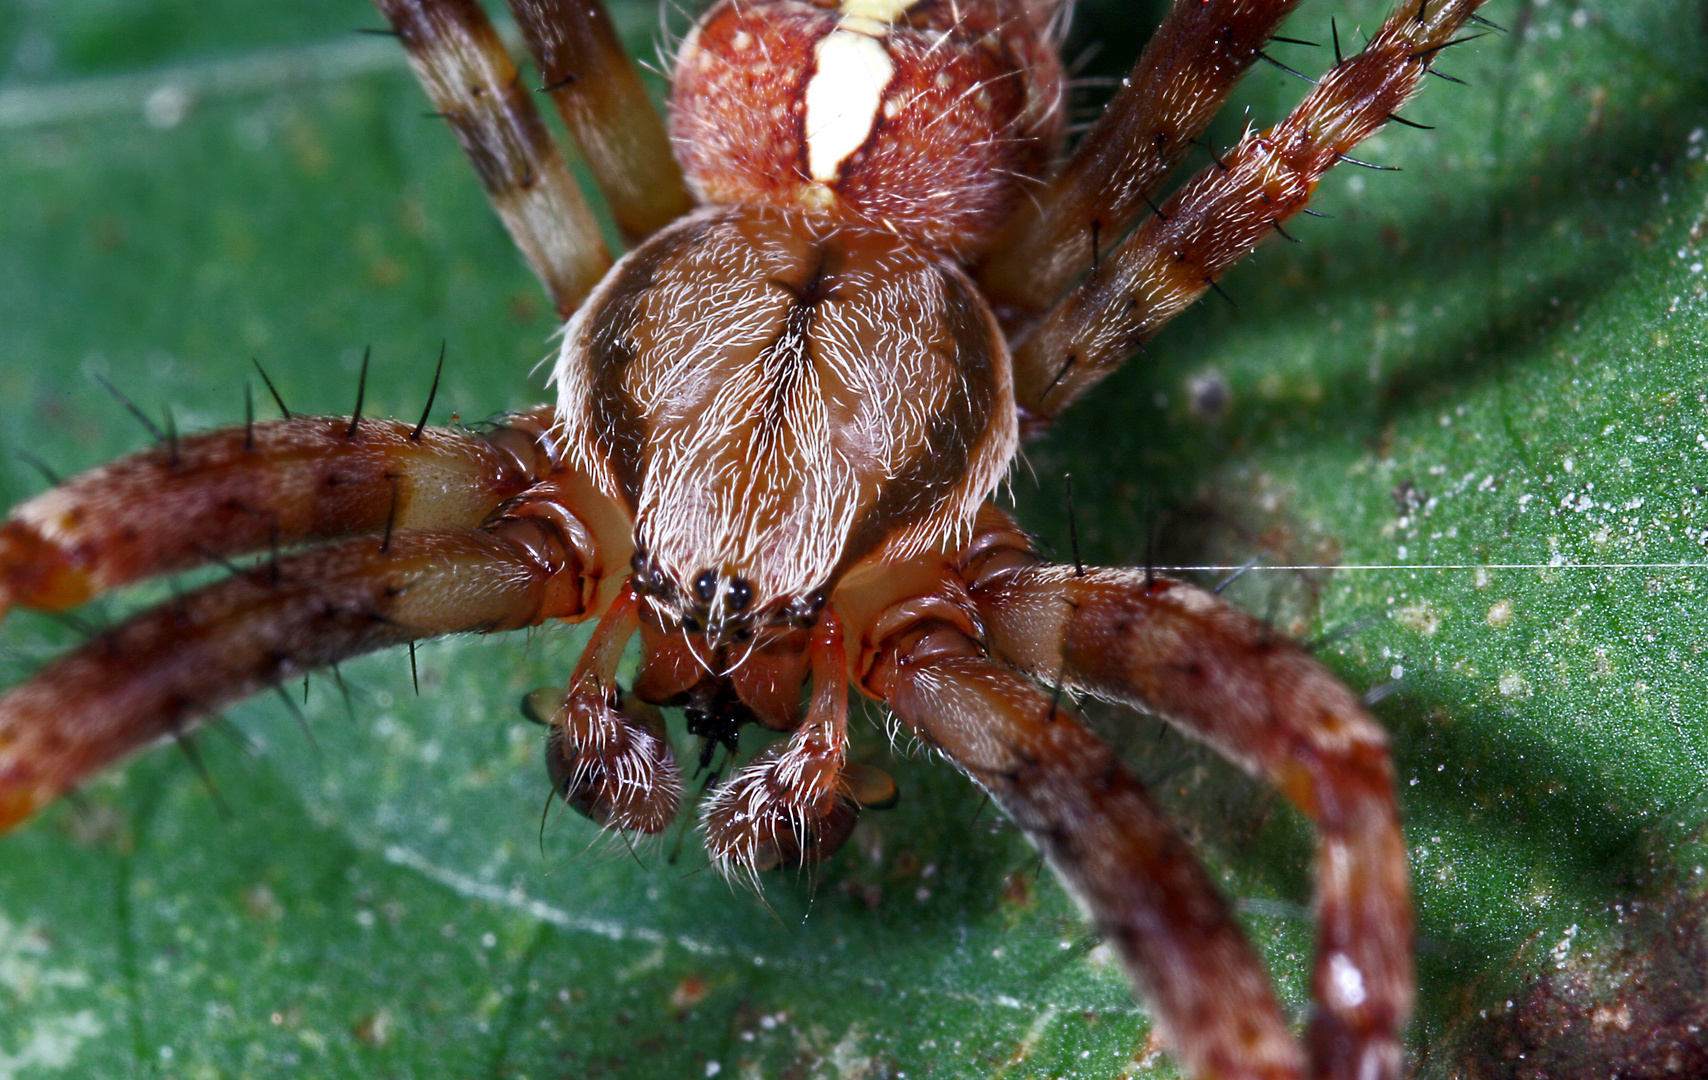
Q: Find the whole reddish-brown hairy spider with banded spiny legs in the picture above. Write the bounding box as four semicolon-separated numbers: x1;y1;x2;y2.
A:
0;0;1503;1077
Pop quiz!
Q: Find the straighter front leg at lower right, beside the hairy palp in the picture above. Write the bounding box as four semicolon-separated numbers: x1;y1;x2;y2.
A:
863;619;1305;1080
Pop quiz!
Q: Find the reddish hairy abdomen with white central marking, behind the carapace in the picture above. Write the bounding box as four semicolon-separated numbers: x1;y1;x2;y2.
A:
670;0;1062;255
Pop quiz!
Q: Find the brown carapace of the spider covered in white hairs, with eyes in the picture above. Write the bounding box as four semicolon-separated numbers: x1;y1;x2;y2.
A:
555;207;1016;637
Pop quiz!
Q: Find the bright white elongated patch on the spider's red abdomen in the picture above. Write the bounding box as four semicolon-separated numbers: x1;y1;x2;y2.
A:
806;29;895;183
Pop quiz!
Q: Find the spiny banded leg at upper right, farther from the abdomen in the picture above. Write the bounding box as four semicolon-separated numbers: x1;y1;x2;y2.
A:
1015;0;1483;431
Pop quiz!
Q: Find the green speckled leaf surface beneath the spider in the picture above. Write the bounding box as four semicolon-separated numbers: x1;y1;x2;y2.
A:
0;0;1708;1080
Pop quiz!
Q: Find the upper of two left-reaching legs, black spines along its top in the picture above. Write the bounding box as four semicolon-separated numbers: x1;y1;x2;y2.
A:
0;408;552;615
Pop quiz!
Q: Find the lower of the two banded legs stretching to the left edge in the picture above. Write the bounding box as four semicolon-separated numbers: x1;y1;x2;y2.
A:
0;518;582;831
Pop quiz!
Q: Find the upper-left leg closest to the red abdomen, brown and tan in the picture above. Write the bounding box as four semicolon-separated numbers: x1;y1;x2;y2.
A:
509;0;693;244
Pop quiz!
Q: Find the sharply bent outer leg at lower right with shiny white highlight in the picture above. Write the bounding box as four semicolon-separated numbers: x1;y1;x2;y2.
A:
963;509;1413;1080
